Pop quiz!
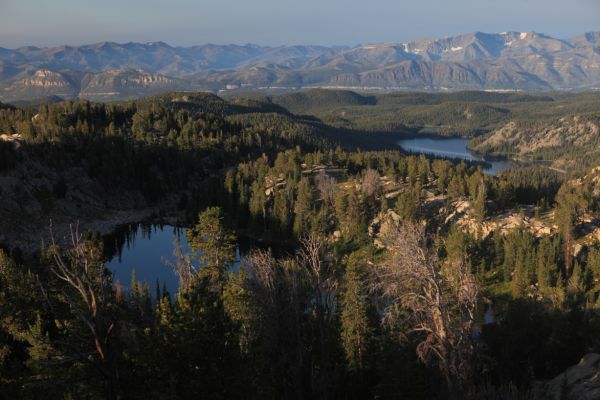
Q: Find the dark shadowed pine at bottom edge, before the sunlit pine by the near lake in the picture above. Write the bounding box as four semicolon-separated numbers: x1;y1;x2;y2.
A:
161;273;245;399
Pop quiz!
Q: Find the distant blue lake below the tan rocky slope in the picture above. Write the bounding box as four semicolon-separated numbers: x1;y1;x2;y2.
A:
398;137;511;175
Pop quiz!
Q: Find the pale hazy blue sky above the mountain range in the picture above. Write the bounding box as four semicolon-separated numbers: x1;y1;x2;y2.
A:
0;0;600;47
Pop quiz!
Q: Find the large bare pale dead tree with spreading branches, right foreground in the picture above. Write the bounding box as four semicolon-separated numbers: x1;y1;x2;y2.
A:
372;223;478;393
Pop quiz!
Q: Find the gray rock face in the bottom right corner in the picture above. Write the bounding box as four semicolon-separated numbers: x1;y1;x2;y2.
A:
537;353;600;400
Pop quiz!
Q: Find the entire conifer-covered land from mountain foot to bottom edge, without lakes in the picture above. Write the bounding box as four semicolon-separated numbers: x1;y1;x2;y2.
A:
0;92;600;399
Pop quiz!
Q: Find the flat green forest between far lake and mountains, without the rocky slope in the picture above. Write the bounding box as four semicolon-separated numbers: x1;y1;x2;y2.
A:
258;89;600;136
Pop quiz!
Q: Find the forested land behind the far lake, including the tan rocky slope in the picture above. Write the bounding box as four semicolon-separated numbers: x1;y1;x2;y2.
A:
255;89;600;172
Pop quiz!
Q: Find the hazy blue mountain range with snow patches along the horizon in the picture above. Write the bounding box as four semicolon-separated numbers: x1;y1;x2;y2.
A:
0;32;600;101
